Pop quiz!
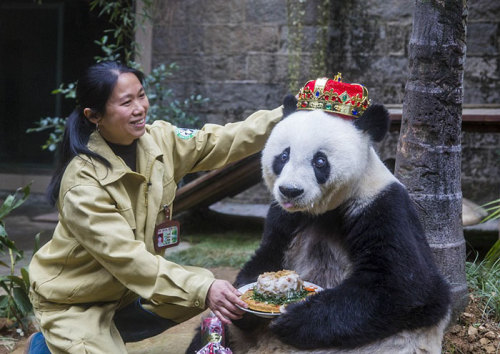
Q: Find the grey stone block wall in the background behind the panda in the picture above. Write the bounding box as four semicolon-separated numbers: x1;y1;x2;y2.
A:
153;0;500;203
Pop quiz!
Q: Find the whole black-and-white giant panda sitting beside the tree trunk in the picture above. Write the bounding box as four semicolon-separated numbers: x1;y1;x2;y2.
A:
228;90;450;354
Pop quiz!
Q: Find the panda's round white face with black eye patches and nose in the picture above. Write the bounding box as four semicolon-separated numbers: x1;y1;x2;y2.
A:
262;111;370;214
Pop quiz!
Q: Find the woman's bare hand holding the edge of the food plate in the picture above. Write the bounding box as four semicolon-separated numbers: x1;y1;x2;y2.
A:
206;279;247;324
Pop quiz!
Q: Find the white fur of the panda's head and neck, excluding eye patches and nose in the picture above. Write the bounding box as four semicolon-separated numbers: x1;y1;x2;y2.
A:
262;110;397;214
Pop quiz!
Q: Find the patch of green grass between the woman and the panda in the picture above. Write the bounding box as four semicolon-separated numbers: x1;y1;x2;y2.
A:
166;232;261;268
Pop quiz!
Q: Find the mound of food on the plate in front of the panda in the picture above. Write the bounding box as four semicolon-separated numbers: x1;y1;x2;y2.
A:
241;270;317;313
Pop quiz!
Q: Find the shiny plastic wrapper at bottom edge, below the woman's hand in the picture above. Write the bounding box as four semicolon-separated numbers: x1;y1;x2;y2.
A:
196;313;233;354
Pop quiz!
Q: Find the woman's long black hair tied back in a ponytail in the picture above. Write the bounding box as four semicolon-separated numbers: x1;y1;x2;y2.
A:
47;61;144;205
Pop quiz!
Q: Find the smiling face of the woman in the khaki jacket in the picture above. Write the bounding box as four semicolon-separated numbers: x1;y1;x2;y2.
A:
97;73;149;145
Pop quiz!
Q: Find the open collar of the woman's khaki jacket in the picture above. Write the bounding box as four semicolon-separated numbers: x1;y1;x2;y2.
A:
87;131;162;185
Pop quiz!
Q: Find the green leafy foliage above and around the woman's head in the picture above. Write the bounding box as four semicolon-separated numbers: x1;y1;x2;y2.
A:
27;0;209;151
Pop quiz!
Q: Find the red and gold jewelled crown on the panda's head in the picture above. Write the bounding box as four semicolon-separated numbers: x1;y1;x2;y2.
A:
297;73;370;119
